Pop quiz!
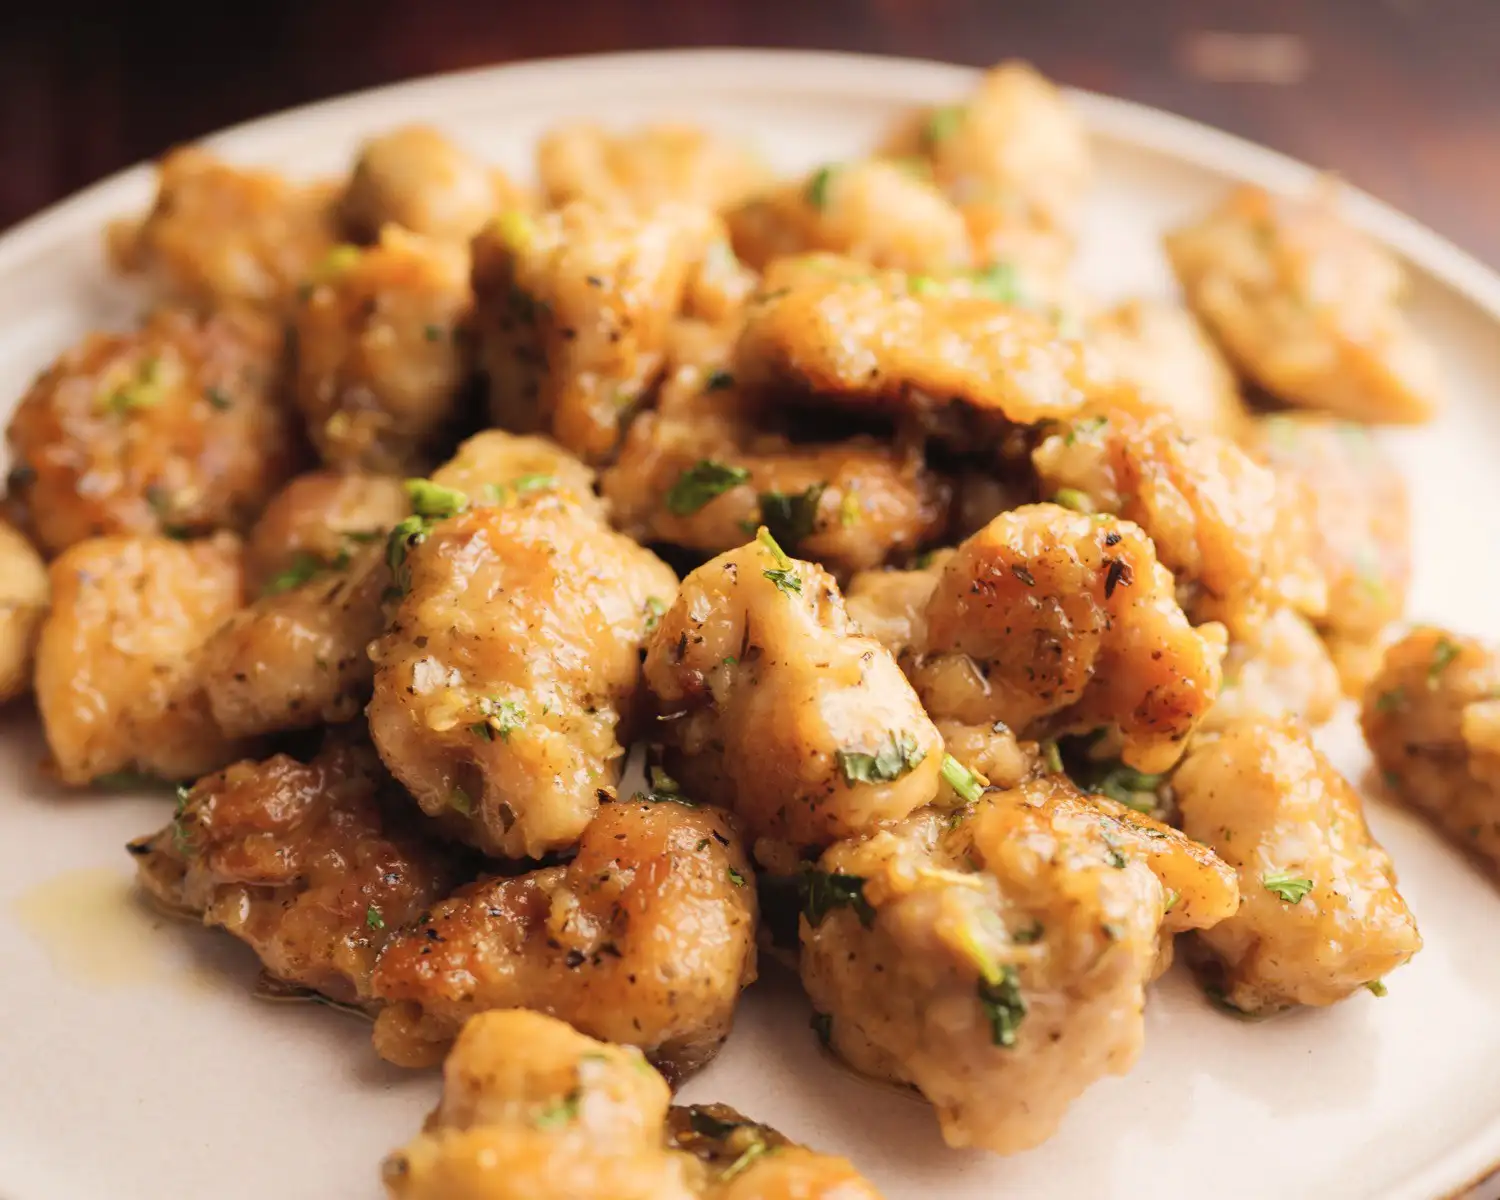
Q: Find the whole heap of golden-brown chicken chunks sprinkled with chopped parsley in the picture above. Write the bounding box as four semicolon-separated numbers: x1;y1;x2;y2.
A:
0;65;1500;1199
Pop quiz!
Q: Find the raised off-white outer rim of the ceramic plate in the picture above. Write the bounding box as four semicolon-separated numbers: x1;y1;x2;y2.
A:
0;47;1500;1197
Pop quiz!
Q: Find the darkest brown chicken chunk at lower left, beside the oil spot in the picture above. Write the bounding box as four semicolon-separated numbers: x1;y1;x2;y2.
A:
129;734;458;1004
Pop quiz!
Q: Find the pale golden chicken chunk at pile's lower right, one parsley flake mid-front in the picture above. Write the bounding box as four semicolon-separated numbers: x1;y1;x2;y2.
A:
1173;722;1422;1013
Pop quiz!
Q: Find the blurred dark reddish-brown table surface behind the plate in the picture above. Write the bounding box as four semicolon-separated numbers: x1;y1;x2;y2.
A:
0;0;1500;264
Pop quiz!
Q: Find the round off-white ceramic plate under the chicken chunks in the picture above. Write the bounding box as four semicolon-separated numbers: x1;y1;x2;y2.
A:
0;51;1500;1200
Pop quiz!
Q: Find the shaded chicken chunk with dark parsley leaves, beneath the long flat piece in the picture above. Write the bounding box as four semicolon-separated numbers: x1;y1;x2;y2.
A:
602;324;948;572
